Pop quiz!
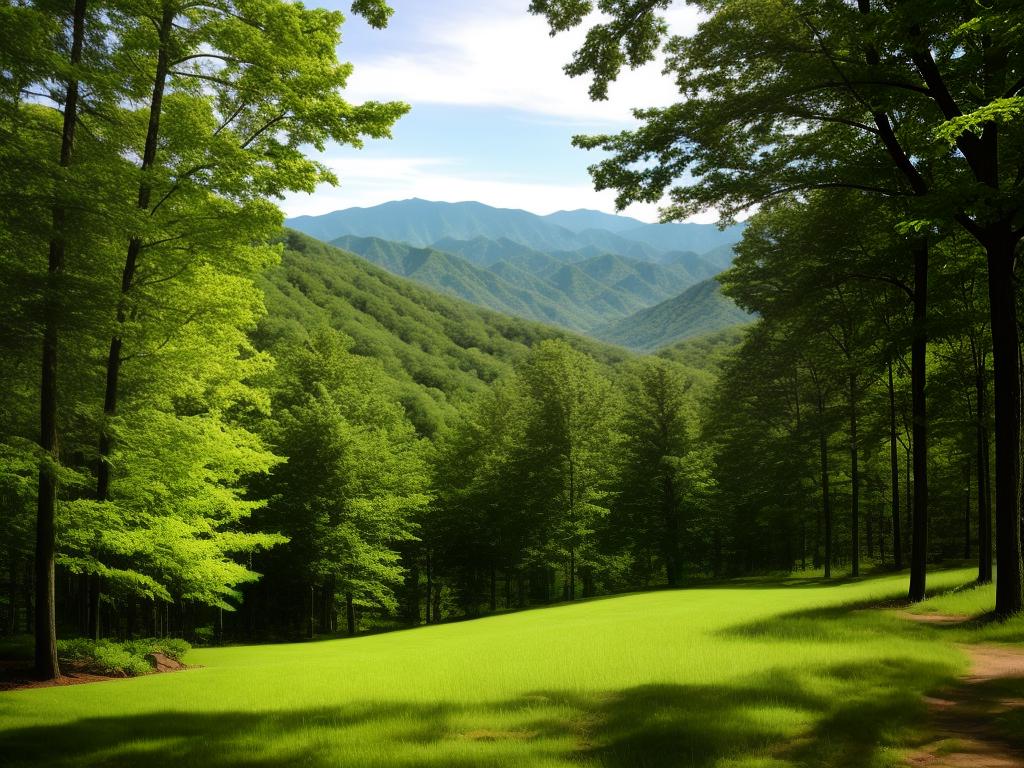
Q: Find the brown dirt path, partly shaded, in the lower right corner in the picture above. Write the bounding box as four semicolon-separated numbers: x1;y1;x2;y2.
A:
908;645;1024;768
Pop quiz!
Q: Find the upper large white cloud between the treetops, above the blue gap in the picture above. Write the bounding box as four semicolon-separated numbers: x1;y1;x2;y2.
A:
346;2;697;123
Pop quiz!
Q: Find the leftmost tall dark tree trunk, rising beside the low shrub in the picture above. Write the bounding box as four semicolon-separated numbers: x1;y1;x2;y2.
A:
35;0;86;680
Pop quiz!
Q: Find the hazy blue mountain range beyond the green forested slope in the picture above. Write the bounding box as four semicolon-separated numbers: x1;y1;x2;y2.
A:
286;200;749;351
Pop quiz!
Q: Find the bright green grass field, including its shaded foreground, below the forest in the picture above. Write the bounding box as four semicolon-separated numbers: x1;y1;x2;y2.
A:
0;570;1024;768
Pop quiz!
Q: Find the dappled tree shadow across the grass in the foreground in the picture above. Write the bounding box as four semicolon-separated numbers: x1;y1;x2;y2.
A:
0;663;949;768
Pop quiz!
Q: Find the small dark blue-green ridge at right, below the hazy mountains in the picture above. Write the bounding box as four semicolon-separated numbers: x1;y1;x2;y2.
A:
594;280;752;351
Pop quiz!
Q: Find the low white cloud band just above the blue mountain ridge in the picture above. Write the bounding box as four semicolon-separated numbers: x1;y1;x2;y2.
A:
282;157;716;222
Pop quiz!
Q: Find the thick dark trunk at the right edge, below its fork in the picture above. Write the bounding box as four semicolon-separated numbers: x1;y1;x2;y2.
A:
985;231;1024;617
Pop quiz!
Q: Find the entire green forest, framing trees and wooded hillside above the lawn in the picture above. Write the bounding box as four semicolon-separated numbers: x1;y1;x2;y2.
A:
0;0;1024;688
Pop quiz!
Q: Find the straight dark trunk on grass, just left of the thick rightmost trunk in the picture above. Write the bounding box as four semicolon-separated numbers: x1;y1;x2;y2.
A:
908;241;928;602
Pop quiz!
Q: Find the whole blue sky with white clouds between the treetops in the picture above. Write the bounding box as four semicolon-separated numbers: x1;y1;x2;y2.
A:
282;0;707;221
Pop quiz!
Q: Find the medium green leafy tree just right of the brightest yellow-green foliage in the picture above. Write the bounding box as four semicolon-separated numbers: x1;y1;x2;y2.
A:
259;330;430;626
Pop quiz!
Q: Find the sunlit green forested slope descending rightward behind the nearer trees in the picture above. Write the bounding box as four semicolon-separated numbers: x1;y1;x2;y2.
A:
255;231;629;433
